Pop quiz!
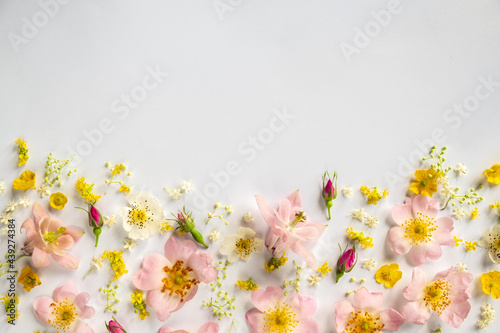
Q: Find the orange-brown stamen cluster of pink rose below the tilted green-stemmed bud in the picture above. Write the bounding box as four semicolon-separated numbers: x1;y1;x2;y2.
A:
161;260;200;302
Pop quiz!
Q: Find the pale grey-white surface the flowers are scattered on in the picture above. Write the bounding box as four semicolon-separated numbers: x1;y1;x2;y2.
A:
0;0;500;332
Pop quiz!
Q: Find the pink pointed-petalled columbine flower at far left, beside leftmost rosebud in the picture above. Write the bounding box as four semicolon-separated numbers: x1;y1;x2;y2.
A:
21;202;84;269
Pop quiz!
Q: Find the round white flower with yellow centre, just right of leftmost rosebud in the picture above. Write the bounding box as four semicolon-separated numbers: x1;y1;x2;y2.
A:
119;192;165;239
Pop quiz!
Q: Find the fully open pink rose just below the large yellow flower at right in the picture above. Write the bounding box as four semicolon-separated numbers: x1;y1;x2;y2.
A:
387;195;455;265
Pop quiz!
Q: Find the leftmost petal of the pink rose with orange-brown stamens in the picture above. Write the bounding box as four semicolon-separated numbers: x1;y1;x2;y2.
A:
132;253;172;290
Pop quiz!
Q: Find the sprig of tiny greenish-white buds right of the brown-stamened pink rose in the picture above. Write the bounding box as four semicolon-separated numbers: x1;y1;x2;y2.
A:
202;261;236;323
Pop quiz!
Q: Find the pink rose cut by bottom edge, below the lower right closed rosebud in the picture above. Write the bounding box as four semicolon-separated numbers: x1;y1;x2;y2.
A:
335;287;405;333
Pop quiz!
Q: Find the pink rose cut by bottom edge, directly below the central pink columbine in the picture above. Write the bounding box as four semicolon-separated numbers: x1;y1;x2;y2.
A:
245;286;321;333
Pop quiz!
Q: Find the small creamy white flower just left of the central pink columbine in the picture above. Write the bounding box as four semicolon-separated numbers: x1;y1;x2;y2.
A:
220;227;264;263
